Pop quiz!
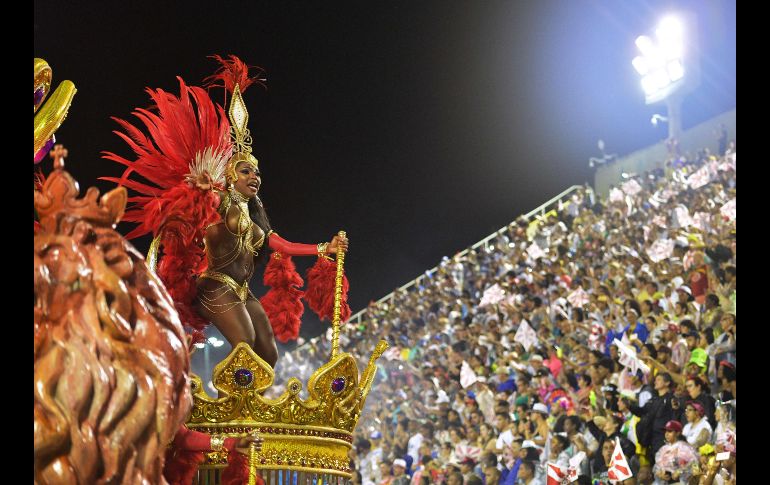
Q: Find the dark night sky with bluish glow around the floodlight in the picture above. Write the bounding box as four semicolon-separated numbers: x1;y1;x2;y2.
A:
34;0;736;336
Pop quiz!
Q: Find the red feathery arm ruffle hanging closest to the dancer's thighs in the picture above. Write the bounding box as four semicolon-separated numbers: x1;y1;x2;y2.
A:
259;252;305;343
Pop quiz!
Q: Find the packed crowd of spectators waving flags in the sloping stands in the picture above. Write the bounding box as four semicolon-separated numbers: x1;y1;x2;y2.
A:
279;142;736;485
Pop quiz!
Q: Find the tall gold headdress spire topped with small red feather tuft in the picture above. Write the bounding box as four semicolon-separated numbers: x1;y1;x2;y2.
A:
204;54;265;184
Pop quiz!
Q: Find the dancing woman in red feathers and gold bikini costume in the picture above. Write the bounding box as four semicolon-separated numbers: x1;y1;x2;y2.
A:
103;55;350;367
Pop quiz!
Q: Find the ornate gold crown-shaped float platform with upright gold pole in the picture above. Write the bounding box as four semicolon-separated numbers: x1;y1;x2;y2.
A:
187;237;388;484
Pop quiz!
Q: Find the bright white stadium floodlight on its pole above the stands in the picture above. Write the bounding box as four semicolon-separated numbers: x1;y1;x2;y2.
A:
631;13;700;140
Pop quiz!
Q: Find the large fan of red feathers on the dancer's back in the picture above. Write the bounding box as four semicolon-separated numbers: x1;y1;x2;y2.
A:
101;77;232;339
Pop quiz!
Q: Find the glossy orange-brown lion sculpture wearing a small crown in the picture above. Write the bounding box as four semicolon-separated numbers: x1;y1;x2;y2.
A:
34;150;191;484
